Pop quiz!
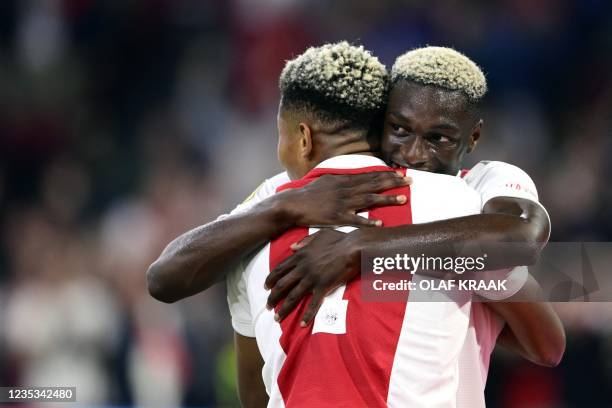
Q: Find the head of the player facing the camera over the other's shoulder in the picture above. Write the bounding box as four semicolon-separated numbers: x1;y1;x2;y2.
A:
382;47;487;175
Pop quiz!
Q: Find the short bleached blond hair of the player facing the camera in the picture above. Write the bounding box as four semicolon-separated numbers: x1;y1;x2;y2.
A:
391;47;487;102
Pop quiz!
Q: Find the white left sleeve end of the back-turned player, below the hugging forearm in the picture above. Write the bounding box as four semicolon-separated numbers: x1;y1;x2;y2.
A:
226;262;255;337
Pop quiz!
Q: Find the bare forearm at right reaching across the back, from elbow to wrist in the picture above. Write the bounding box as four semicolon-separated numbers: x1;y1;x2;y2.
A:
353;213;544;270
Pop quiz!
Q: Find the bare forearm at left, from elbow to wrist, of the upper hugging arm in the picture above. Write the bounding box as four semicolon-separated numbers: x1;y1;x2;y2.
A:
147;197;291;303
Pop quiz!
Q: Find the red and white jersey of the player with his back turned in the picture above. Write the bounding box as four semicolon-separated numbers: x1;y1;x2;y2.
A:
228;155;481;407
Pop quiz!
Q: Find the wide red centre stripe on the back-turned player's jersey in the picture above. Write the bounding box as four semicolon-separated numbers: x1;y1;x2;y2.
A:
270;166;412;408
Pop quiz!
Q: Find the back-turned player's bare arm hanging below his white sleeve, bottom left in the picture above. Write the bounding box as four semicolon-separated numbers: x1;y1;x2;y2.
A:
234;332;269;408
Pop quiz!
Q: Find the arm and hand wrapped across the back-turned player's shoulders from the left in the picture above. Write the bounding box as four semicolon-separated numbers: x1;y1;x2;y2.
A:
147;172;410;303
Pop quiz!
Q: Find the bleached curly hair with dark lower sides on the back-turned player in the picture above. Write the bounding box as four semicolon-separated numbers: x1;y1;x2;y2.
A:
279;41;388;124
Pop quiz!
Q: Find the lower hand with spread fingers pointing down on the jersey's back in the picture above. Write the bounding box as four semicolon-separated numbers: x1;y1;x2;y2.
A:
265;228;361;327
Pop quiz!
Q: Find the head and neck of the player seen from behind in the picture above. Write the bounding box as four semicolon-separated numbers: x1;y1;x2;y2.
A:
278;41;388;179
